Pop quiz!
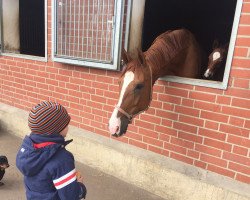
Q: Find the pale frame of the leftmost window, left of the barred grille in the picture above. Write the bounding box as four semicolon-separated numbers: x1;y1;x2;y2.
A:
0;0;48;62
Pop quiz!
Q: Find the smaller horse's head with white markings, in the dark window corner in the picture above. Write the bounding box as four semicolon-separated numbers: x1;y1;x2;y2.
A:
203;40;228;79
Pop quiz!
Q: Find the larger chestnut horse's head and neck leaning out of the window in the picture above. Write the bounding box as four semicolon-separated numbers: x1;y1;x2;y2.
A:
109;29;203;137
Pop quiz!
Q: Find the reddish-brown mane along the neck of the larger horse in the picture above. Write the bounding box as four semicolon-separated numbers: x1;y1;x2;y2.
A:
145;29;190;68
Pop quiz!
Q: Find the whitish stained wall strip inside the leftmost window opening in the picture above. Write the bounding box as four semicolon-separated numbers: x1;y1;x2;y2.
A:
2;0;20;52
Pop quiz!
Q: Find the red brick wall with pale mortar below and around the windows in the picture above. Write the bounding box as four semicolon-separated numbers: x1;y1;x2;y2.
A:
0;0;250;184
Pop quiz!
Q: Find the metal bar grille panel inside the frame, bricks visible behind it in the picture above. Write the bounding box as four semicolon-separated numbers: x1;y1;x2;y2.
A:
55;0;115;63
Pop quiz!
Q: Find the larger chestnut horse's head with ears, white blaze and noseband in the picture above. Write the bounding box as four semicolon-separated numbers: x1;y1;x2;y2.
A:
109;50;153;137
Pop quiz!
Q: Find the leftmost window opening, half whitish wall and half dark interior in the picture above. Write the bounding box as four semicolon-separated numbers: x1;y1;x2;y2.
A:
1;0;46;57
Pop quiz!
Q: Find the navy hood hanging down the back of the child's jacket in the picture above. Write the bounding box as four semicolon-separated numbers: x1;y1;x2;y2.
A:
16;134;69;176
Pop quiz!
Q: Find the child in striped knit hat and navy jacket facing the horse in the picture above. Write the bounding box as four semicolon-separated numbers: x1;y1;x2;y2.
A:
16;101;87;200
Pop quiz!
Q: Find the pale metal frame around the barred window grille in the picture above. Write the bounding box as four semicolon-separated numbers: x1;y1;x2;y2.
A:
52;0;125;70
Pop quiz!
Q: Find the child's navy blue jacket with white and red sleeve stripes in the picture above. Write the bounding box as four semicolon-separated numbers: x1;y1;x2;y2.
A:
16;133;87;200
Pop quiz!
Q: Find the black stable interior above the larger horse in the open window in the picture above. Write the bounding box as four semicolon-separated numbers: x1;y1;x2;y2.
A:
142;0;237;80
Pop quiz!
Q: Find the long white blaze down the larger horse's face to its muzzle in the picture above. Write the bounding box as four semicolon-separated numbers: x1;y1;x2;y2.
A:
109;71;134;134
